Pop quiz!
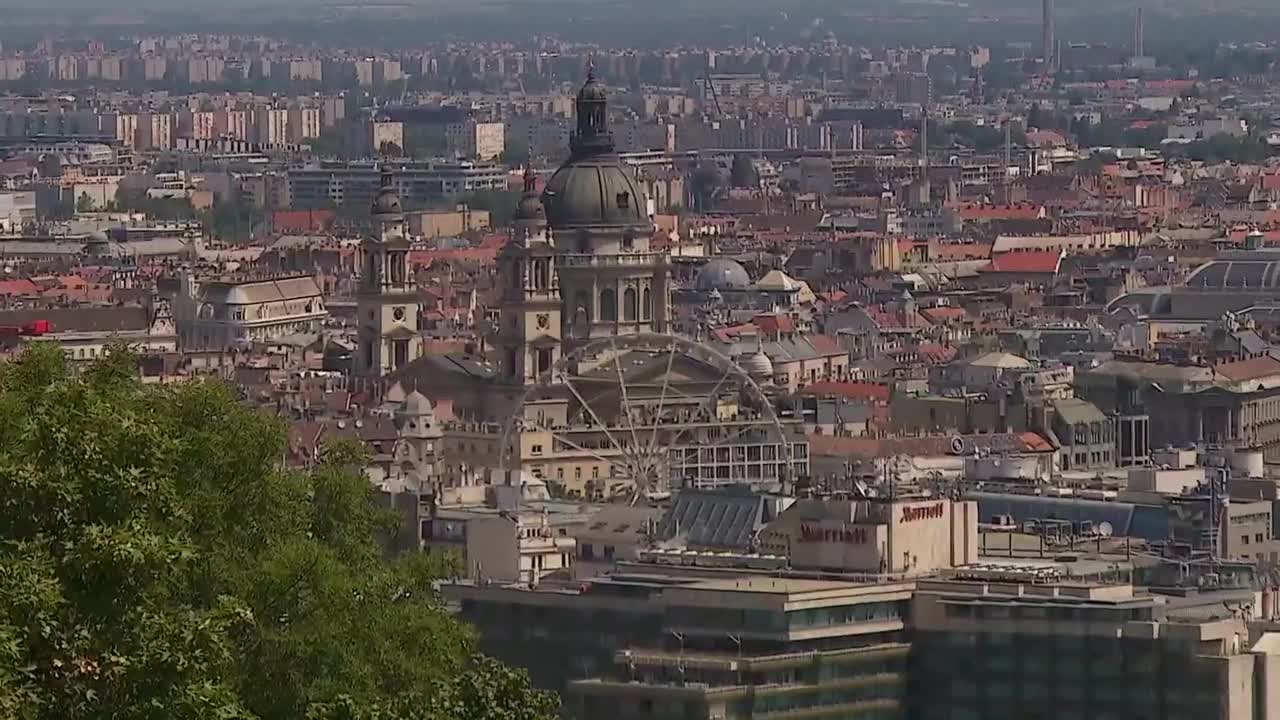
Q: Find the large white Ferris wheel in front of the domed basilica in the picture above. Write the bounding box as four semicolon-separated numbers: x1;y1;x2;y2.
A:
499;333;796;502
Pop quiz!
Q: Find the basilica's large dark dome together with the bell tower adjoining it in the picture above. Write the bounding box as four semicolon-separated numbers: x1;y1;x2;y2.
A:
494;67;671;384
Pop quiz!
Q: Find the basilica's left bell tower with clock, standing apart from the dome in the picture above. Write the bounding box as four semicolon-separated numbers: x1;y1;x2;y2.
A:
356;168;422;378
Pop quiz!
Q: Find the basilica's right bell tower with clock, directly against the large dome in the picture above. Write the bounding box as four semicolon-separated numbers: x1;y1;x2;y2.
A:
497;169;561;384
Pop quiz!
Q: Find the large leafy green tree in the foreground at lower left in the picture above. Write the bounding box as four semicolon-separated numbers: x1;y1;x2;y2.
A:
0;346;557;720
